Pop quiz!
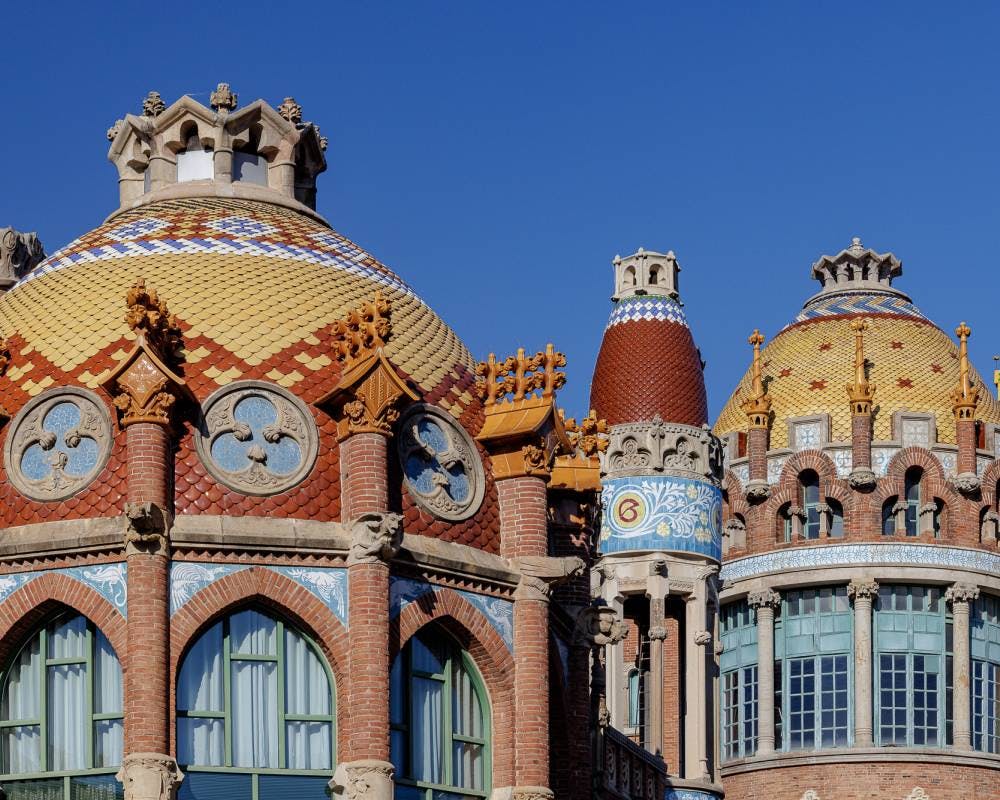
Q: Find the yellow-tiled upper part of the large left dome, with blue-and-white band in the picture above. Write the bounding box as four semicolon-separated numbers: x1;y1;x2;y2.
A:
0;197;472;413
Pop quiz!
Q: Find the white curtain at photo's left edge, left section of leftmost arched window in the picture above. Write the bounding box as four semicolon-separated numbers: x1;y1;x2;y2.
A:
2;635;41;772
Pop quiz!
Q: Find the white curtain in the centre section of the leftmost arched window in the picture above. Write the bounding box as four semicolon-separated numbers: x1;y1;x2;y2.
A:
47;617;88;770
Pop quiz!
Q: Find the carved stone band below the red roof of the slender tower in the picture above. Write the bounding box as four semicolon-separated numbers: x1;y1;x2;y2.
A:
601;417;723;486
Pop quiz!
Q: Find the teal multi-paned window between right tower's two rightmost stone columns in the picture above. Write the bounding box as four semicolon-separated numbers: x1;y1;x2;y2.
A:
873;585;952;747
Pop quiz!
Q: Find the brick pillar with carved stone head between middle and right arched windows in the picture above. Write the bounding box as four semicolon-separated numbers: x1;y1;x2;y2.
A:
331;431;402;800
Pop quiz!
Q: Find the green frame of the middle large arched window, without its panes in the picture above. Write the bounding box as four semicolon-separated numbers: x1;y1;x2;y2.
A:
176;608;337;800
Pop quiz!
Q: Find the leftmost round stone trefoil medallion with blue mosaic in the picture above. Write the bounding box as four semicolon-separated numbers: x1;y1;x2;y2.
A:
4;387;113;501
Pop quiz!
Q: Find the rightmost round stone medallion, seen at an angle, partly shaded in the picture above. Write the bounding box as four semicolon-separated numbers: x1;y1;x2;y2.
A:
396;403;486;520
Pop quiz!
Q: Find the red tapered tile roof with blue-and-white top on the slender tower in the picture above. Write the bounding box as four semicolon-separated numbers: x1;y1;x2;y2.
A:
590;295;708;426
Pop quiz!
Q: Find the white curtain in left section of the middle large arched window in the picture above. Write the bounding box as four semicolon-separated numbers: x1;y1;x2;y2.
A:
177;622;226;767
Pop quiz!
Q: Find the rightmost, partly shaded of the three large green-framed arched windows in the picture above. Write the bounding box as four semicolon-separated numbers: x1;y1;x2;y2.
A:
390;627;490;800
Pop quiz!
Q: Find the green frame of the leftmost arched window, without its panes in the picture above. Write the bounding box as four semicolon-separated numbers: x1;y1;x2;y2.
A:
0;613;124;800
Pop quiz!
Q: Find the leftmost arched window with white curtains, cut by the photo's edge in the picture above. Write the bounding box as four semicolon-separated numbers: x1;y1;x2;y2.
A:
0;614;123;800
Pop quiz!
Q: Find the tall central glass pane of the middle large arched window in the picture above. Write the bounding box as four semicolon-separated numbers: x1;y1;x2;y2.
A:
230;656;278;767
